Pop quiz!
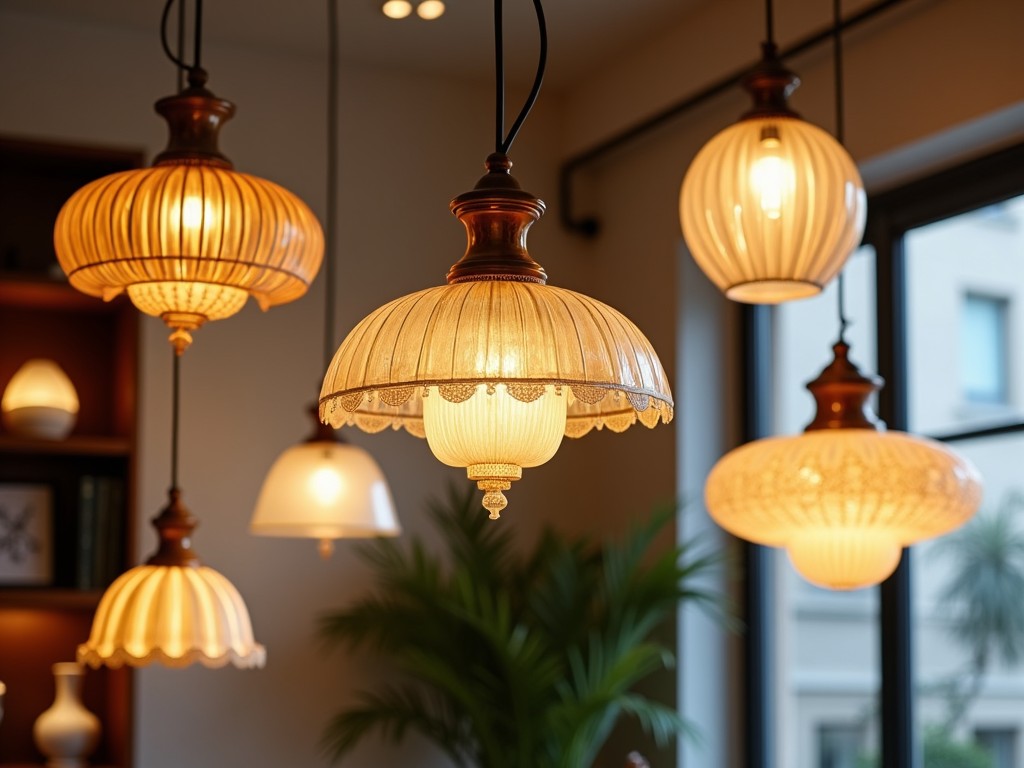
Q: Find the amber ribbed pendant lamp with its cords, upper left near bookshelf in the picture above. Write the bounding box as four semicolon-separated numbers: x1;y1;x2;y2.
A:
53;0;324;349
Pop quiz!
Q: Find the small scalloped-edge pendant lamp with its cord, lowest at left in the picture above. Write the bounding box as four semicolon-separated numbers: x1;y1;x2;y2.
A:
78;351;266;669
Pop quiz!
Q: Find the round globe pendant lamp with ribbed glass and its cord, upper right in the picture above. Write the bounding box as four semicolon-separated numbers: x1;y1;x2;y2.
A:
679;0;866;304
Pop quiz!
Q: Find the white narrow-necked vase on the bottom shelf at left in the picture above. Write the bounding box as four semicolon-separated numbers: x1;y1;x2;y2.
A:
32;662;99;768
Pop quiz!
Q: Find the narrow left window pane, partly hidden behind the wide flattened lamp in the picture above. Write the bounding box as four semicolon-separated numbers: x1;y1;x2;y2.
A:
771;248;880;768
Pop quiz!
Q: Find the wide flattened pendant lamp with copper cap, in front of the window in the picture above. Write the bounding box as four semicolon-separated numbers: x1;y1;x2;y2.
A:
705;341;982;590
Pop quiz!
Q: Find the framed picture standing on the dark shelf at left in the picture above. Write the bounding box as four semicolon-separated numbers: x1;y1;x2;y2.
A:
0;483;53;587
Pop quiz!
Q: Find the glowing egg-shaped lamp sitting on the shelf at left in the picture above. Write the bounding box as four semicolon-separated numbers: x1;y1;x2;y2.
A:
0;357;79;440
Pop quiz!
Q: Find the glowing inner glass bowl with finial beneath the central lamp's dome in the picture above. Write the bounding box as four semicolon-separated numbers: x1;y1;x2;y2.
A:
423;384;569;519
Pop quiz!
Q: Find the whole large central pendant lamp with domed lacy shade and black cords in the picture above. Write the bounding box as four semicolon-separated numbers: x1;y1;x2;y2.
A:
319;0;673;518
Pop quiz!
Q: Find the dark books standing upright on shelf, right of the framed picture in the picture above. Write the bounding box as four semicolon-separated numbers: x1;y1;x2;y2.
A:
75;475;125;590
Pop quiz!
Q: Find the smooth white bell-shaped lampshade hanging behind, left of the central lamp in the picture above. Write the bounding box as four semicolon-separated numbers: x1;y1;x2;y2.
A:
249;411;401;557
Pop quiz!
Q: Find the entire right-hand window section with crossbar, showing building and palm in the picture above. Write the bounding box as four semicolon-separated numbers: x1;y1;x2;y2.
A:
903;196;1024;768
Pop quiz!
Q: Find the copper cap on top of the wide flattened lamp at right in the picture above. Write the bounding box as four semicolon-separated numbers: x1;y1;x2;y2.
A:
804;340;886;432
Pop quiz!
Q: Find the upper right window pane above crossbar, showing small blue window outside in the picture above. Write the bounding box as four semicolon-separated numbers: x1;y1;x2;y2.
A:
904;197;1024;435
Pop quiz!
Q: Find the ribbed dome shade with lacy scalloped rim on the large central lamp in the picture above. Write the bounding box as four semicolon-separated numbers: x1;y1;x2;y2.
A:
319;281;673;437
